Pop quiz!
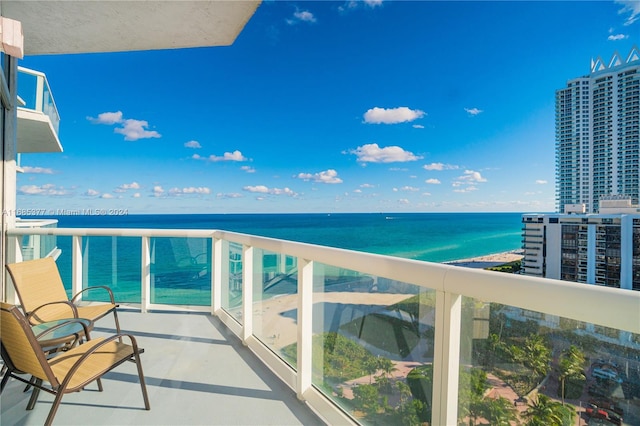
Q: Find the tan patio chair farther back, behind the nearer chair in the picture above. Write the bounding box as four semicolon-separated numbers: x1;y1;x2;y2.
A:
7;257;120;334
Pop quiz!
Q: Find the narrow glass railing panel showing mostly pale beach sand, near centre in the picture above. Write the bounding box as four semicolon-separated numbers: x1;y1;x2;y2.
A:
253;249;298;361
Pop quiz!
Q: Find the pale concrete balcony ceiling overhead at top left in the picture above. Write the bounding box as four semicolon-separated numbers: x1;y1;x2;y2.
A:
0;0;260;55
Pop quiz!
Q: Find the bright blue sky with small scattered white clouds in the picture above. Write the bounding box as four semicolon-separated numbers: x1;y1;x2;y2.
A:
17;1;640;214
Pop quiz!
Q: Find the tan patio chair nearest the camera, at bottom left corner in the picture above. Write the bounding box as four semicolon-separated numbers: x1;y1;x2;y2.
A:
0;302;151;425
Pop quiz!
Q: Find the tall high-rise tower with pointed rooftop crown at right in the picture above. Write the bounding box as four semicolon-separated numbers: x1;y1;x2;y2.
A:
556;47;640;213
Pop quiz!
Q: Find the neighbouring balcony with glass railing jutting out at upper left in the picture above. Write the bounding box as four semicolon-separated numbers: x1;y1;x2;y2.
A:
17;67;62;153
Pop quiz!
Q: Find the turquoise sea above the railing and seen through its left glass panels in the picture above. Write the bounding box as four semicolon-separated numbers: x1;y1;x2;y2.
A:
45;213;521;306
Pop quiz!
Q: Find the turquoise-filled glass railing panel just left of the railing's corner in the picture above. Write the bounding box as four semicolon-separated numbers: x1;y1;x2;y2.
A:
150;237;211;306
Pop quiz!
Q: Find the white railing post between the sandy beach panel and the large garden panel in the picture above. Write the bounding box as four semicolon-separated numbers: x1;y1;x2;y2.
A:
296;259;314;400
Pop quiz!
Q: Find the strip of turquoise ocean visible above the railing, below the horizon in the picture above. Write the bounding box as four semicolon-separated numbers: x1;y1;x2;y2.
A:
54;213;522;262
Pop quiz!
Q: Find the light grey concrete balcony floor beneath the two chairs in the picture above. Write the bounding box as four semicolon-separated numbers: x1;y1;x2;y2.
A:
0;308;324;425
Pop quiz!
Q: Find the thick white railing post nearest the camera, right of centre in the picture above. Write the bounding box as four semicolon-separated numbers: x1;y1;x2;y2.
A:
431;291;462;426
